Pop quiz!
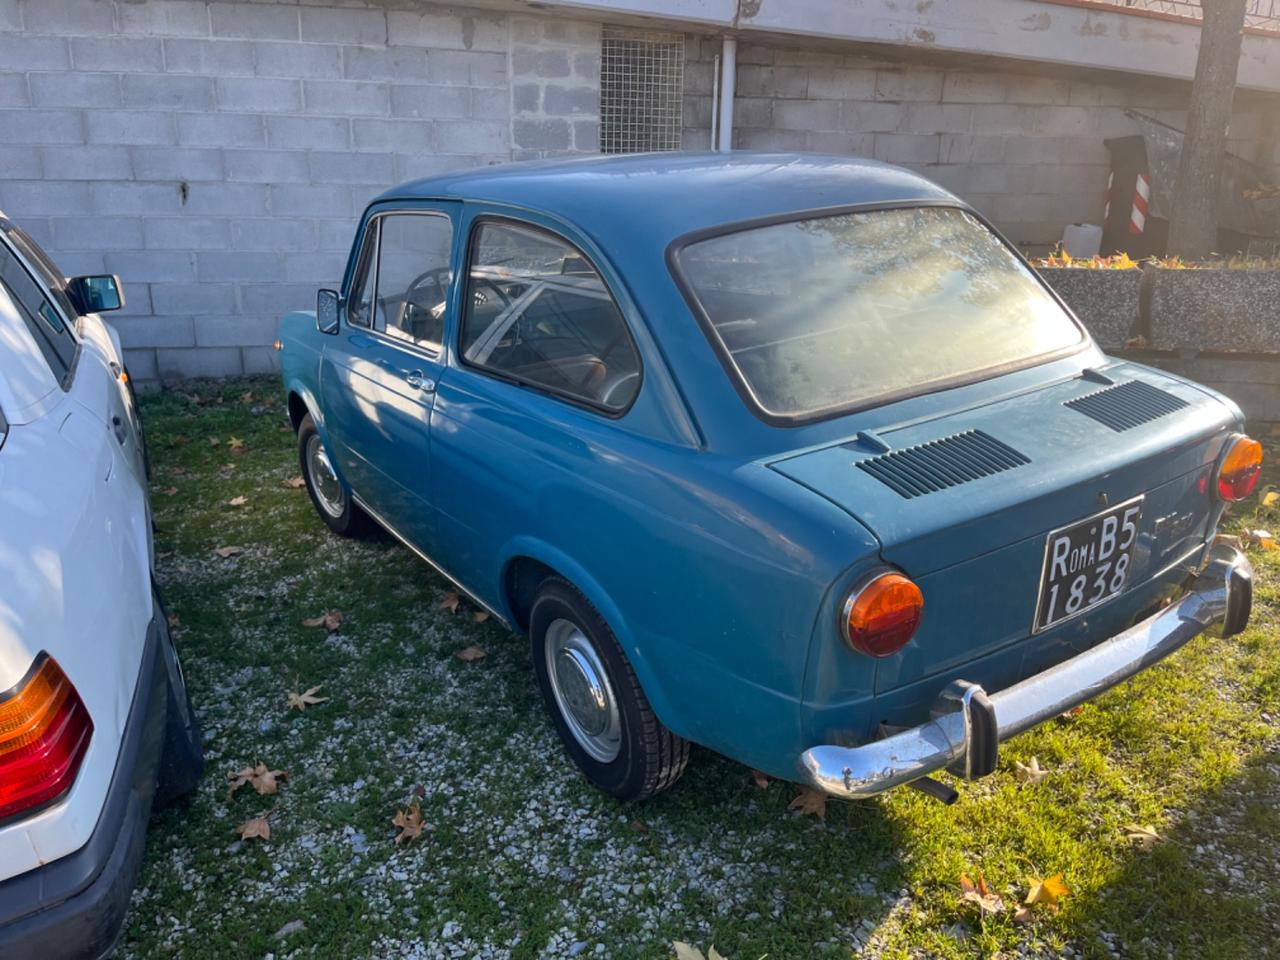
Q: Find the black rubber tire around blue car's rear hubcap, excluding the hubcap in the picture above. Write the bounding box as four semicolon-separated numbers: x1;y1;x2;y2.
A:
529;577;689;801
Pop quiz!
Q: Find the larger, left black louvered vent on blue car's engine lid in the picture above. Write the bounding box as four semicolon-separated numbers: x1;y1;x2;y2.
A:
858;430;1030;499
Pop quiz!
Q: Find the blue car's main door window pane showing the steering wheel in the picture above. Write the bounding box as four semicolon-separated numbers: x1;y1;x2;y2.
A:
374;214;453;349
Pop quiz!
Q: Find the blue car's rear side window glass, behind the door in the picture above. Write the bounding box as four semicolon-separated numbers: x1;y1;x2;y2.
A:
460;221;640;411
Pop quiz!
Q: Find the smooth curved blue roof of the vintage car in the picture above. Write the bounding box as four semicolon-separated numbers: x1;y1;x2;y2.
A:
375;151;961;247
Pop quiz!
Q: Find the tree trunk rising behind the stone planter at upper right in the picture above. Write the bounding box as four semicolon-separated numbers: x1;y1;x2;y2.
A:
1169;0;1248;260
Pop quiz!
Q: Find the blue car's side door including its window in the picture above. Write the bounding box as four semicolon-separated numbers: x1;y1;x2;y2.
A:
320;202;458;550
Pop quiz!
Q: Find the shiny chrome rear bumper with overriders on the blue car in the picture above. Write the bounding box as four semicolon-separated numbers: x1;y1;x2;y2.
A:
800;545;1253;797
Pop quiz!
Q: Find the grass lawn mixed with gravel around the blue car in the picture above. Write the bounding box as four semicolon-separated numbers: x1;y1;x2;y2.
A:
122;380;1280;960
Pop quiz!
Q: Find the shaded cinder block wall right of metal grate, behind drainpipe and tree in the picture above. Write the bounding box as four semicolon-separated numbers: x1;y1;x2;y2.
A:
684;37;1280;247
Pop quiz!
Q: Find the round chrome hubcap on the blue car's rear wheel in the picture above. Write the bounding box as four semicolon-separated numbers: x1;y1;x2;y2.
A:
544;620;622;763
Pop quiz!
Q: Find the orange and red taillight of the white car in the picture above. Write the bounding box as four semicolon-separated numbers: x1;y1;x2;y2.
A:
0;653;93;820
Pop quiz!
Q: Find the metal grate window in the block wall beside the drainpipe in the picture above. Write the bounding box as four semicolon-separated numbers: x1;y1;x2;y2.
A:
600;27;685;154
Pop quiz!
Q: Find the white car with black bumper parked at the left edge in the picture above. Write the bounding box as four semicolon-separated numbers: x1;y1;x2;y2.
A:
0;214;202;960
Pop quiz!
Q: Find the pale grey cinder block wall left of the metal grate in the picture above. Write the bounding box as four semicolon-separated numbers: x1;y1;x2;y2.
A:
0;0;599;380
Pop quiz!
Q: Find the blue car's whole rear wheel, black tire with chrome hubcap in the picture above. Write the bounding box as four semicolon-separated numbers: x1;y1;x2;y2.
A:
529;577;689;800
